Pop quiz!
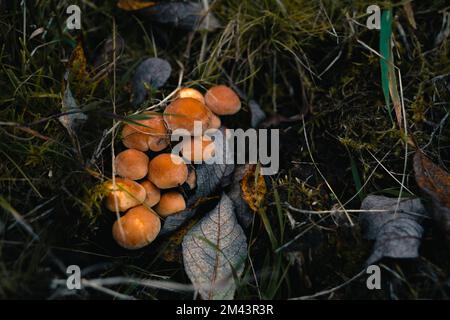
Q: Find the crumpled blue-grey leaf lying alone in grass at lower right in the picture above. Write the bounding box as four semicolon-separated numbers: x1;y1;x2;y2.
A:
359;195;427;265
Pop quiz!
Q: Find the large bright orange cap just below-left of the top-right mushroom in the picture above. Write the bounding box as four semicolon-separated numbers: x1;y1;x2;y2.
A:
164;98;211;135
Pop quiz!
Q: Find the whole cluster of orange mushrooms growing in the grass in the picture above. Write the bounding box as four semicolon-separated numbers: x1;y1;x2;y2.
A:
105;85;241;249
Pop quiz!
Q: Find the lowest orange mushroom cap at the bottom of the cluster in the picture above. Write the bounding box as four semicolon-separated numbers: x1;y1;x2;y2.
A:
112;206;161;250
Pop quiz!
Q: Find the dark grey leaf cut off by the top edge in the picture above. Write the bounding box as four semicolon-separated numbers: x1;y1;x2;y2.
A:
141;2;220;31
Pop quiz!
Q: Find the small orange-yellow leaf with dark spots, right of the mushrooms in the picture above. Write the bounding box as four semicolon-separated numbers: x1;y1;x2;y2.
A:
241;165;267;212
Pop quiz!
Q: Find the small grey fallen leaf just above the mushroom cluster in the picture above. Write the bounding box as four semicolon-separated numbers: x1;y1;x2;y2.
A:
132;58;172;105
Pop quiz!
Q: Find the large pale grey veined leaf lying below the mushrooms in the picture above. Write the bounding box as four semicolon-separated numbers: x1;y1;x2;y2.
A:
182;194;247;300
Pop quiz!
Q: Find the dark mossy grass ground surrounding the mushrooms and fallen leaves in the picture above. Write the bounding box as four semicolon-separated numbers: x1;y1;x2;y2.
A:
0;0;450;299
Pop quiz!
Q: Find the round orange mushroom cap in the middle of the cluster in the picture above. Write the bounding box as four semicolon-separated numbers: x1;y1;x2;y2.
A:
148;153;188;189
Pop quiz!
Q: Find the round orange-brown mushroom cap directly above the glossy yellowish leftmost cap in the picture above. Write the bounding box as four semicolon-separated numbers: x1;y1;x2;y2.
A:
115;149;148;180
